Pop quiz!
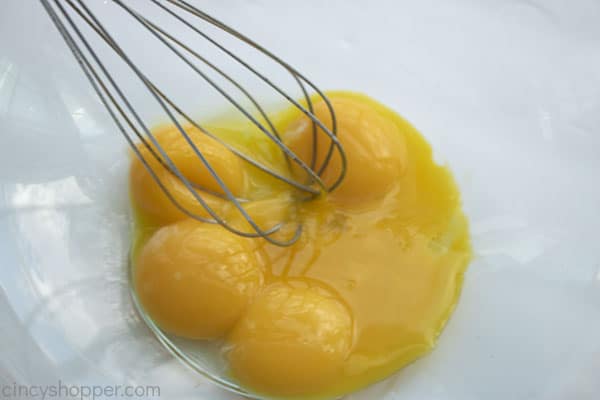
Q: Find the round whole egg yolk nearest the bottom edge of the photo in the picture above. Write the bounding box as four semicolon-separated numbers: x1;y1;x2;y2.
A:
228;282;352;395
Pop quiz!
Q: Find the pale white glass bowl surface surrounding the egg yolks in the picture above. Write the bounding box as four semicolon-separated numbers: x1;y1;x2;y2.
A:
0;0;600;400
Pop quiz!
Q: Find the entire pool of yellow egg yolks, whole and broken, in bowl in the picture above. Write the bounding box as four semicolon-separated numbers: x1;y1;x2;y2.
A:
130;92;471;399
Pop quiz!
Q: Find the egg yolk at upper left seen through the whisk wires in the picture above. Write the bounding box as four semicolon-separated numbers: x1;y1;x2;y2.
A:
129;127;246;224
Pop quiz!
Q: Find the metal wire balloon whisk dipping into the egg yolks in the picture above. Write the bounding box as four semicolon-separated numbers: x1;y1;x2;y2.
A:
40;0;346;246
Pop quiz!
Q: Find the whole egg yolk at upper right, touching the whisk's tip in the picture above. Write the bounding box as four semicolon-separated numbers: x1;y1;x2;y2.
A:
284;97;406;205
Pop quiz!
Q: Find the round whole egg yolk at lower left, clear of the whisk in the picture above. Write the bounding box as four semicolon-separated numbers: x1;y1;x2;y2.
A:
134;219;263;339
